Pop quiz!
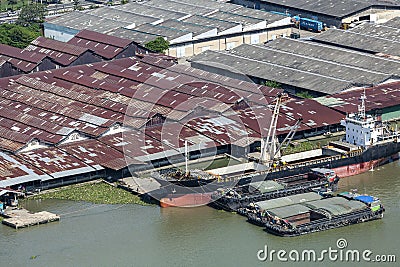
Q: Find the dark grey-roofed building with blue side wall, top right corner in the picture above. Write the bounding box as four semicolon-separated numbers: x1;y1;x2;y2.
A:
231;0;400;28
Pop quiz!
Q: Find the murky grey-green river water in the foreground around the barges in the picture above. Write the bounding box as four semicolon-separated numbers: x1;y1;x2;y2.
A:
0;162;400;267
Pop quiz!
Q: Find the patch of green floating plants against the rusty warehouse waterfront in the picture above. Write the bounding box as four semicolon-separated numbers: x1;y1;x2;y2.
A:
33;183;148;205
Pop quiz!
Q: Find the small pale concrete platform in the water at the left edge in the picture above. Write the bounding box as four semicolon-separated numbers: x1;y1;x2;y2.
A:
2;208;60;229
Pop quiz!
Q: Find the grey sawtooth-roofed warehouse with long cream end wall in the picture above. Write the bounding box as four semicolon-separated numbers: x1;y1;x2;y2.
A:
44;0;292;58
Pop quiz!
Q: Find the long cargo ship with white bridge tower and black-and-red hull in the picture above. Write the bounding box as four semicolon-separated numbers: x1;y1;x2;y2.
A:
155;93;400;206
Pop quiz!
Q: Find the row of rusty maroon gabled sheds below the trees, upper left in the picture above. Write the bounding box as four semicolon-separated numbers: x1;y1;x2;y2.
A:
0;30;149;78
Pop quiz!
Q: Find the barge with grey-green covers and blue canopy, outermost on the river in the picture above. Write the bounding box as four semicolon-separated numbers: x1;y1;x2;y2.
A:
239;192;385;236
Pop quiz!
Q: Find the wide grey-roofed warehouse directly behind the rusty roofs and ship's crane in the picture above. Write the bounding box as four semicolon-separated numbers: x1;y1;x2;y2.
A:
190;35;400;96
